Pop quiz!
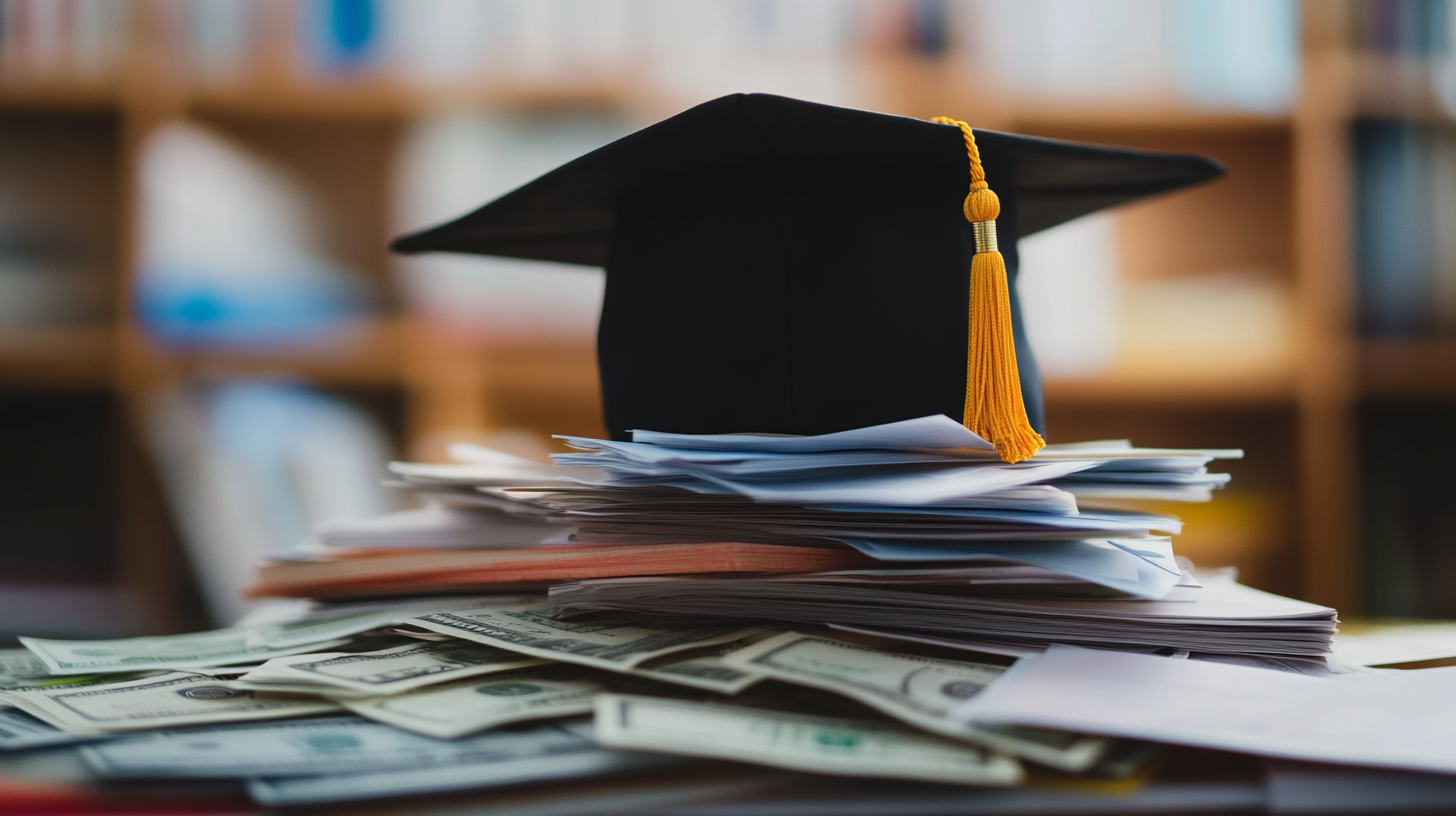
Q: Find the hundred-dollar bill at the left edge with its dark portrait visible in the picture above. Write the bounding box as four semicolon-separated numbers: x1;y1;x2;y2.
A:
0;673;339;733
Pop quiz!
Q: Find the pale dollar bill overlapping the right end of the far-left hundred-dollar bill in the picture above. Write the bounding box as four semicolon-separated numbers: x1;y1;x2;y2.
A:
242;638;546;697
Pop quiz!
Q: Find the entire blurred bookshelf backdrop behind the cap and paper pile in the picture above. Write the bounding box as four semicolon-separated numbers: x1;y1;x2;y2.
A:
0;0;1456;637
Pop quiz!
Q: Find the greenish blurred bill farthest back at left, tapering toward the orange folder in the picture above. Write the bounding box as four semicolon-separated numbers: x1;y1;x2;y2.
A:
20;600;515;675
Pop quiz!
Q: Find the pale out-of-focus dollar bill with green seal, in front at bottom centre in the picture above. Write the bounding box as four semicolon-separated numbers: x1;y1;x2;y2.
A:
596;694;1022;785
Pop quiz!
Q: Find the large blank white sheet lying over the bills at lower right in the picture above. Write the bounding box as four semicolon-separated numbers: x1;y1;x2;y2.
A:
957;646;1456;772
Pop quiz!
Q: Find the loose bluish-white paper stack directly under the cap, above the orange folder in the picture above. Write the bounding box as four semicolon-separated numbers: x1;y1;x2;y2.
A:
349;417;1239;597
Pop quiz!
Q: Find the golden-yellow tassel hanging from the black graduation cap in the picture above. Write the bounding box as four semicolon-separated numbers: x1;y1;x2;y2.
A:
930;117;1047;462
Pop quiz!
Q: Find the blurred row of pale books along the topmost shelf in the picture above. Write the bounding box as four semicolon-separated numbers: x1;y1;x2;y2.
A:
0;0;1299;112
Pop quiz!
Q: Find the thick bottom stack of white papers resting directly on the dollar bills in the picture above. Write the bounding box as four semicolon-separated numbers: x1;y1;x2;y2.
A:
552;573;1335;659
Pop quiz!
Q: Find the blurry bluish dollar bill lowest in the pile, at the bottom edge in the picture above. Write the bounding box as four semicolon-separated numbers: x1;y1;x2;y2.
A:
248;721;683;813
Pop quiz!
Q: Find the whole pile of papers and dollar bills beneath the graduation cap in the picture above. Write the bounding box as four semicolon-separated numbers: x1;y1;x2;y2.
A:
0;417;1335;810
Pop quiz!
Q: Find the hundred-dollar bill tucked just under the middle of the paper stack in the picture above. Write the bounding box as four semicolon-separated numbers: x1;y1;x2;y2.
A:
409;600;763;672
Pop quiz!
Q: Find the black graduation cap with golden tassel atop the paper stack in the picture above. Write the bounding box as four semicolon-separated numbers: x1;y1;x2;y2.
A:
392;93;1223;460
